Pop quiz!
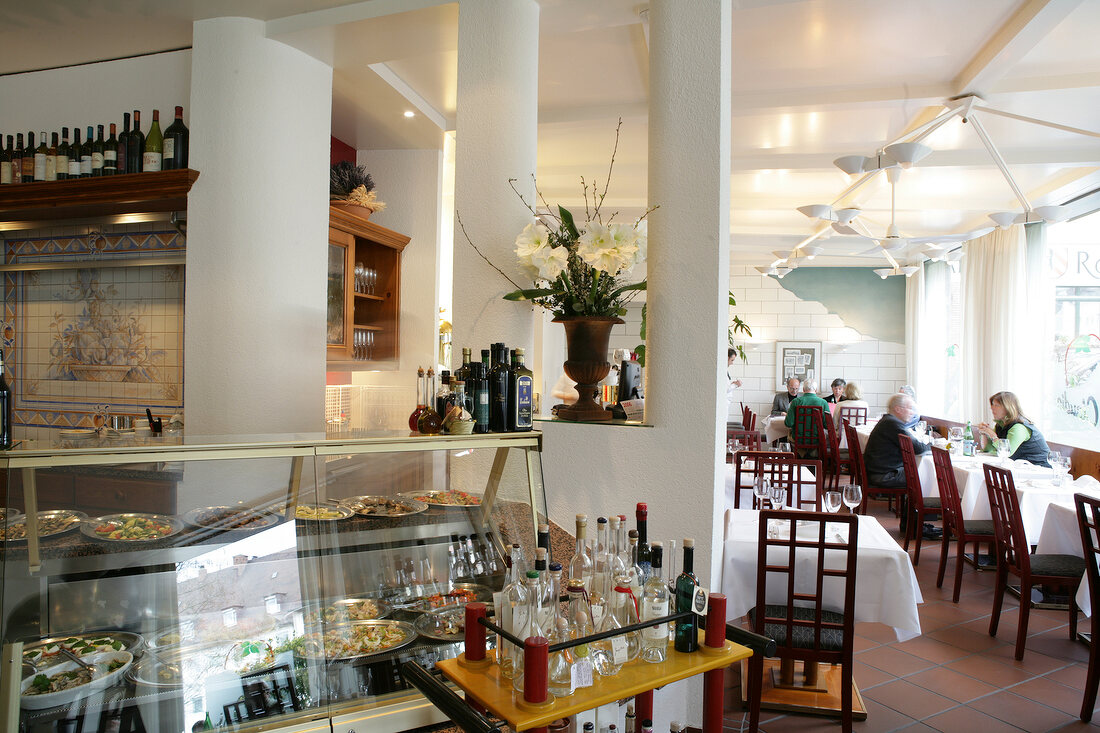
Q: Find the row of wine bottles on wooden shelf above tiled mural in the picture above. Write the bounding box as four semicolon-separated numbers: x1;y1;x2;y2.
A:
0;107;188;184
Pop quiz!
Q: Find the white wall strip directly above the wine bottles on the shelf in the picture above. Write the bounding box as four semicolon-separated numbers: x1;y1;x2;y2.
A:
0;51;191;134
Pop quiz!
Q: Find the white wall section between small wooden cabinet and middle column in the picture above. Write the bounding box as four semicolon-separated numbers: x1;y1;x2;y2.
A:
352;150;442;387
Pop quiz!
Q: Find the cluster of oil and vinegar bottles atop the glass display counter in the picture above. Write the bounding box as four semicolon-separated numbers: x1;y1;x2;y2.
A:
409;343;535;435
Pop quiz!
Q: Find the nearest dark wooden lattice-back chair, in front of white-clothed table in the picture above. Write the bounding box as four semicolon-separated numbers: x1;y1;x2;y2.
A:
748;512;859;733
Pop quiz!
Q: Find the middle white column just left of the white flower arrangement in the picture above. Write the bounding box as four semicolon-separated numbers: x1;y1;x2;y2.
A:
453;0;539;357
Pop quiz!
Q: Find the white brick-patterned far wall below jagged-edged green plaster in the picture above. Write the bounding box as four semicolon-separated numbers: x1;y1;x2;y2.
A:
729;264;902;416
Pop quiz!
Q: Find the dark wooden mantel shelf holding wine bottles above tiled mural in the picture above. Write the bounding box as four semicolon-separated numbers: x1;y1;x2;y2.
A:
0;168;199;221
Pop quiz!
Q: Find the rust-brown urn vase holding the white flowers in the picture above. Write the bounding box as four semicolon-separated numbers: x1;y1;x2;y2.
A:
554;316;625;422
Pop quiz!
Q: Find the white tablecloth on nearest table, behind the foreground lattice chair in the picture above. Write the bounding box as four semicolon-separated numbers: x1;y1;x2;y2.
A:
722;510;924;642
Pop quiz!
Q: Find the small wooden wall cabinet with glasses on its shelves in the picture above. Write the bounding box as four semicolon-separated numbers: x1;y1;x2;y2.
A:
327;206;409;370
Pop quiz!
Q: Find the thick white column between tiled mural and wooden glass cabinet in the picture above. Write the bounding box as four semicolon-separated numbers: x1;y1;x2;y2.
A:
185;18;332;435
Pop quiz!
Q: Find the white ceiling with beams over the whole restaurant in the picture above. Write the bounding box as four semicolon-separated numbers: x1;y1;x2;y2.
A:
0;0;1100;266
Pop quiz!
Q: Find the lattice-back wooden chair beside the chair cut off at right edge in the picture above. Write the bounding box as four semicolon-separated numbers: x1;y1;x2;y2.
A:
982;463;1085;660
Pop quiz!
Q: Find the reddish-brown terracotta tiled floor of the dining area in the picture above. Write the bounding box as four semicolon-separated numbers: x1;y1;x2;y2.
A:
725;502;1100;733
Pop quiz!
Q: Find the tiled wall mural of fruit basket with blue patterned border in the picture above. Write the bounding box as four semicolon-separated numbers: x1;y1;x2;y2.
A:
2;225;186;438
